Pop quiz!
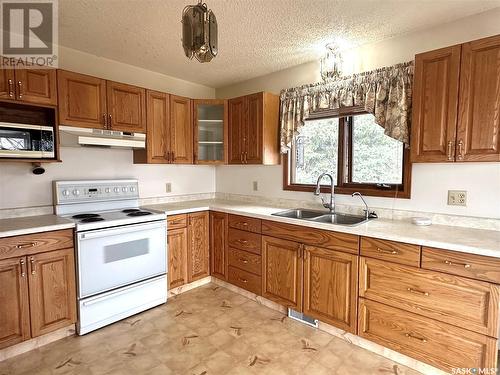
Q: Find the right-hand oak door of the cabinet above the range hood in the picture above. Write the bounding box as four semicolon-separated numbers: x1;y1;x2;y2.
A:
106;81;146;133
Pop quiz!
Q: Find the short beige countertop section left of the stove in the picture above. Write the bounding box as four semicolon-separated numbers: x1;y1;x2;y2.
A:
0;215;75;238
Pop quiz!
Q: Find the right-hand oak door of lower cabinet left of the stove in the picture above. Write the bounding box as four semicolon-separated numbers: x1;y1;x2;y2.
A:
28;249;76;337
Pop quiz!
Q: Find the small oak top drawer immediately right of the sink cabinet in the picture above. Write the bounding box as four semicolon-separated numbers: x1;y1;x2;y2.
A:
360;237;420;267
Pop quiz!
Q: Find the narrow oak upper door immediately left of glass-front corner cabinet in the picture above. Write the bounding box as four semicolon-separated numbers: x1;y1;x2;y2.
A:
170;95;193;164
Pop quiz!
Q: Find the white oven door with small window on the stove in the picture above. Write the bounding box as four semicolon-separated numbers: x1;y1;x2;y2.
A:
77;221;167;299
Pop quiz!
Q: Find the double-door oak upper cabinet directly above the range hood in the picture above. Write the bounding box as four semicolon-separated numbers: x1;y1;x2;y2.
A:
57;70;146;133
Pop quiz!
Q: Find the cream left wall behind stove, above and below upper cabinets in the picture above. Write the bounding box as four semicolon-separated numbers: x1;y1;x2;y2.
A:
0;47;215;209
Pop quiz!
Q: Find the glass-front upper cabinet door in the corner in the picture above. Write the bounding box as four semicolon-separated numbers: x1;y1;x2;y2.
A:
194;99;227;164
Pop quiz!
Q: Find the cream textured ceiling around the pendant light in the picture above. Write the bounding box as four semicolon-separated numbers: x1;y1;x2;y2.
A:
59;0;500;88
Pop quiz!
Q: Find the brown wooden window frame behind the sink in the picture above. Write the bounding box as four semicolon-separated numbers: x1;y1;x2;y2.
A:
283;107;411;199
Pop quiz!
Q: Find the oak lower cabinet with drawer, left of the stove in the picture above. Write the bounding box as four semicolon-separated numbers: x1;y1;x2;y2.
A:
0;230;76;348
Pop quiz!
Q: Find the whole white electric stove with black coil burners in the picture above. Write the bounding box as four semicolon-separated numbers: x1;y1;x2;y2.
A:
54;180;167;335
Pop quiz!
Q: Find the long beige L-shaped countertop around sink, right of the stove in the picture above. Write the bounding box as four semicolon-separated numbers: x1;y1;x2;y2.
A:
146;199;500;258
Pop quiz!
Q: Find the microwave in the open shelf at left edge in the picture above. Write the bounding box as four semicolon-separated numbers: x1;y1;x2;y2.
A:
0;122;55;159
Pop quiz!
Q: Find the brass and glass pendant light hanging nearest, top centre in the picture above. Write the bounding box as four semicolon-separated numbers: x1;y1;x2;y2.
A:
181;0;218;63
